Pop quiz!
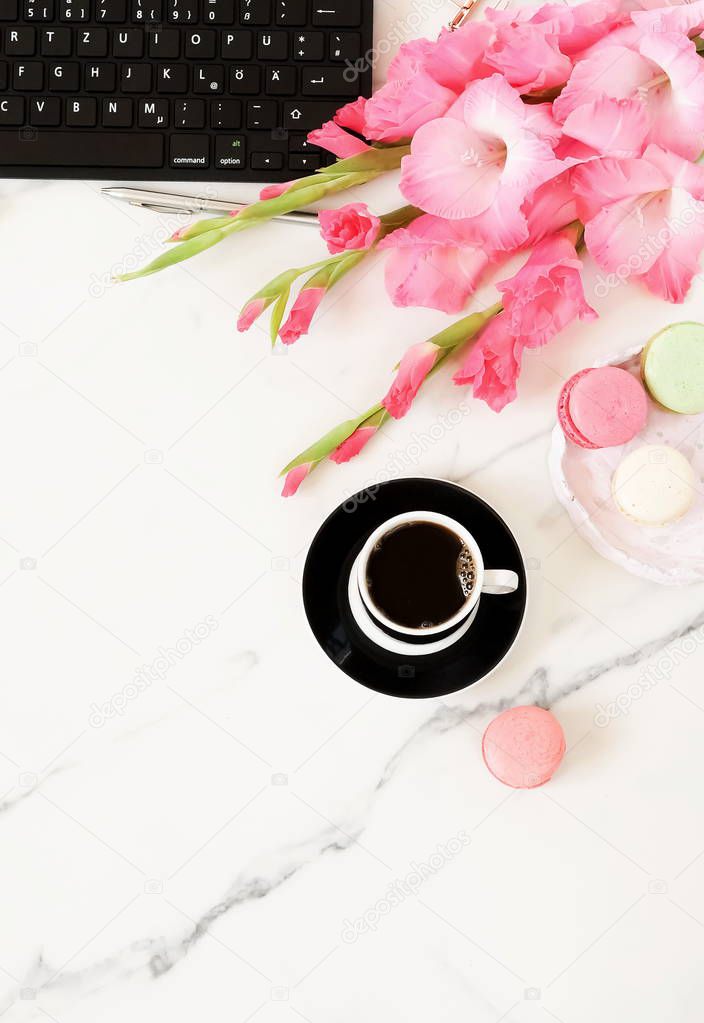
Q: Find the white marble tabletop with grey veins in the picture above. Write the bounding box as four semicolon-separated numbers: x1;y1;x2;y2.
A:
0;5;704;1023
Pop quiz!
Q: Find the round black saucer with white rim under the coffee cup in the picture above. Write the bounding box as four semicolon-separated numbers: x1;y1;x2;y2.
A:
303;479;526;698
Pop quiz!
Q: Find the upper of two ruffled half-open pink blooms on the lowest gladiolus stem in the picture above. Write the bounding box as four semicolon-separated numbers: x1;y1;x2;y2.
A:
496;234;597;348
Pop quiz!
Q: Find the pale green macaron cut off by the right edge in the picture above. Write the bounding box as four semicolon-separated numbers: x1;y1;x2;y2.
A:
641;322;704;415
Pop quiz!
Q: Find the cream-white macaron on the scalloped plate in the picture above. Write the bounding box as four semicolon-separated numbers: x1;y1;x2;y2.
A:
611;444;696;527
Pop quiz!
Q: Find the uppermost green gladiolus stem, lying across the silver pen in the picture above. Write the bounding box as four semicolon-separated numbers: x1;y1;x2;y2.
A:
117;145;410;281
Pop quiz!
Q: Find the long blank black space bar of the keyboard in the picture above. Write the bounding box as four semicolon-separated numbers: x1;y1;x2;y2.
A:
0;129;164;170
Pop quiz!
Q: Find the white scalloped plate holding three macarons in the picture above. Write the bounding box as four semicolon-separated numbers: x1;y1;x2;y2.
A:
548;347;704;586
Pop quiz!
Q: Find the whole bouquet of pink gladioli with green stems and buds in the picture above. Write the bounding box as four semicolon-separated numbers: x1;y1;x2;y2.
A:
122;0;704;496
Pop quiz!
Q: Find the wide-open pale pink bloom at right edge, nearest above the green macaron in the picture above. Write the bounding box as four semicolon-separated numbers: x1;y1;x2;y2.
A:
572;145;704;302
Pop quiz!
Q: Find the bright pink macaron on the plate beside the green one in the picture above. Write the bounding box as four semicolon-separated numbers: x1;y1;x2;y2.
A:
558;366;648;448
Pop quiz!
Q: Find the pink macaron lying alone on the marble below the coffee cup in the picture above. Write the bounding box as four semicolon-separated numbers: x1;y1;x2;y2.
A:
482;707;565;789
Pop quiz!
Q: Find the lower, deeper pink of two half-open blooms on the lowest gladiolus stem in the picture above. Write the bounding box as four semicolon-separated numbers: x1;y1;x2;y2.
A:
452;313;523;412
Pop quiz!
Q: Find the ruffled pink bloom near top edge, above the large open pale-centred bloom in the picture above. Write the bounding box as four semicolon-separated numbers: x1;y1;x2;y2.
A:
486;25;572;93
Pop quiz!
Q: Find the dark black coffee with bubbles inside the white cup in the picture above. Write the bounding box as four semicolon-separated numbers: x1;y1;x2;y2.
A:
366;521;475;629
